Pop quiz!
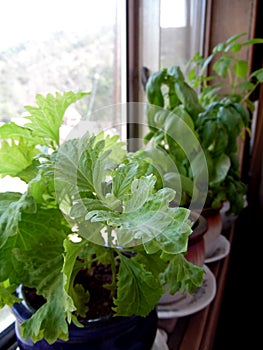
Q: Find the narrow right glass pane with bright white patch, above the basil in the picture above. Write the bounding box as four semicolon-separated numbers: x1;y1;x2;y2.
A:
160;0;206;67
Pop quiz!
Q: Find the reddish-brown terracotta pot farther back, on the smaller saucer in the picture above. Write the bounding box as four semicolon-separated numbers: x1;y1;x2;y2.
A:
202;208;223;258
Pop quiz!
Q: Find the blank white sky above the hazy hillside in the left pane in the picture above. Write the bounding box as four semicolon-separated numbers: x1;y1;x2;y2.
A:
0;0;117;51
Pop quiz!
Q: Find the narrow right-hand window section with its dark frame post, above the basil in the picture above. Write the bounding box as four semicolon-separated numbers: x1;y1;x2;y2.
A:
127;0;206;150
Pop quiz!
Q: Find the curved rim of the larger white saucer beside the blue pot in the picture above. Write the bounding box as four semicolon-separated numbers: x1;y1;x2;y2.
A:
157;265;216;319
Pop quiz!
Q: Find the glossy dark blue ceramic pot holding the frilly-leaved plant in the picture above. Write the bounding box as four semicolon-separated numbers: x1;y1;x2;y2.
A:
12;303;158;350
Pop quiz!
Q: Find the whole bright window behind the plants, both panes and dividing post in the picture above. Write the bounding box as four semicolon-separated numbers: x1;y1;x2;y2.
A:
0;0;205;342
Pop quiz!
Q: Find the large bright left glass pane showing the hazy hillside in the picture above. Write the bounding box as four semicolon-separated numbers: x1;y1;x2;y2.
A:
0;0;126;137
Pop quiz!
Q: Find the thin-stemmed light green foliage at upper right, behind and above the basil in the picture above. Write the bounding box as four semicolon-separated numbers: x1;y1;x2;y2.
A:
186;33;263;108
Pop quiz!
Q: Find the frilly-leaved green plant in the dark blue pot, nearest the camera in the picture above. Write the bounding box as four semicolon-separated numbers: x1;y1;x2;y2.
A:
0;91;204;349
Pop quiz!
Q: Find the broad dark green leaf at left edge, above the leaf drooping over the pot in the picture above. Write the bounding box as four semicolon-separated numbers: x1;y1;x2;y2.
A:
0;209;71;286
